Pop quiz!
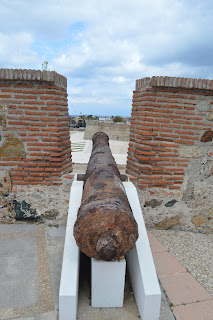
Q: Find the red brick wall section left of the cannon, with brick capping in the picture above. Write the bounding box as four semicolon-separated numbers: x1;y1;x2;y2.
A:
0;69;72;185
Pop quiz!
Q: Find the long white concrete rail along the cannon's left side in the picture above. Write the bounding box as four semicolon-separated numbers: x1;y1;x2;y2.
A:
59;179;83;320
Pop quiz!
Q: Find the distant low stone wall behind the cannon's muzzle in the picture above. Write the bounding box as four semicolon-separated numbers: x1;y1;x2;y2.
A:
84;120;130;141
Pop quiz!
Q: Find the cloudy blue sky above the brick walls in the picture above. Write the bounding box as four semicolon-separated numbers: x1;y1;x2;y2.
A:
0;0;213;116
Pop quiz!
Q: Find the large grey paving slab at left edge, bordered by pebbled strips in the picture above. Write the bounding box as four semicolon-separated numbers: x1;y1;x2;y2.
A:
0;236;39;309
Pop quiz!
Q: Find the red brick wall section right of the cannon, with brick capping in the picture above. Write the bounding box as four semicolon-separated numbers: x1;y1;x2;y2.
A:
127;77;213;189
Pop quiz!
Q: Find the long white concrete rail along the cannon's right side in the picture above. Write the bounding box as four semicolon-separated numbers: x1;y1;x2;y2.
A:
123;182;161;320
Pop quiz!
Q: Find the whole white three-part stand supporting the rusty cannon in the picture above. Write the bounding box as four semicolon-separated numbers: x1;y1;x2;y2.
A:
59;177;161;320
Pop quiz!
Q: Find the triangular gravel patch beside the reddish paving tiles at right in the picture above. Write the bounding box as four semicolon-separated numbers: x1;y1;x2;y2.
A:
150;229;213;295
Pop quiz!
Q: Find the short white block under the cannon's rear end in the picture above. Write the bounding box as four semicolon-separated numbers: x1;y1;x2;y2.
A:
91;258;126;308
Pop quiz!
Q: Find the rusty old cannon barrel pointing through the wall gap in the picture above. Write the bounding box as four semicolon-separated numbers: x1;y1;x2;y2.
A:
74;132;138;261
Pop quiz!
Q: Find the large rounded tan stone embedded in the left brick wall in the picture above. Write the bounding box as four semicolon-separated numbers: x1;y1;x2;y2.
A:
0;137;26;158
